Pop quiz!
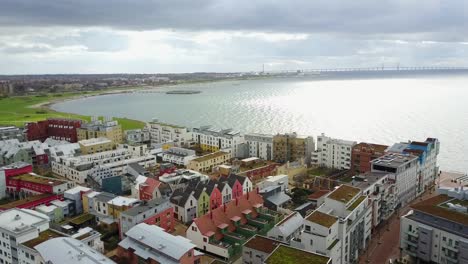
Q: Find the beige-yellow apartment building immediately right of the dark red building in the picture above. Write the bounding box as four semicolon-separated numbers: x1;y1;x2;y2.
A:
77;117;123;144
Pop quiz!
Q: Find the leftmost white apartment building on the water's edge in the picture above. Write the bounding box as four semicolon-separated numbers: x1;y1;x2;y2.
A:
146;119;192;147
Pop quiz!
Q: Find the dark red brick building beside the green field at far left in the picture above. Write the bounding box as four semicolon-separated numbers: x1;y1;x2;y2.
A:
25;118;82;143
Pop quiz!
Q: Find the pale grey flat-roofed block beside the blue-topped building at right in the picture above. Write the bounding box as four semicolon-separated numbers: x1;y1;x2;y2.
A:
371;153;422;205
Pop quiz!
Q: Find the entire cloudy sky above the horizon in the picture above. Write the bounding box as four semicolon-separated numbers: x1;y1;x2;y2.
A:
0;0;468;74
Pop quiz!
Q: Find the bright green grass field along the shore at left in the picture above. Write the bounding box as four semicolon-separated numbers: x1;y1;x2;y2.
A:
0;92;144;130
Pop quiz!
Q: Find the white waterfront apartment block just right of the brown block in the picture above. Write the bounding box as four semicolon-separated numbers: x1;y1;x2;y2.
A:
311;133;357;170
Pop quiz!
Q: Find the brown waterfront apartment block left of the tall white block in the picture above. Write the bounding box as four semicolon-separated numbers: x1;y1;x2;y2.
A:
272;133;315;164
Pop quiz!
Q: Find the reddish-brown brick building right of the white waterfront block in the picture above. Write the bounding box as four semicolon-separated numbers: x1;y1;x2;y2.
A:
351;142;388;174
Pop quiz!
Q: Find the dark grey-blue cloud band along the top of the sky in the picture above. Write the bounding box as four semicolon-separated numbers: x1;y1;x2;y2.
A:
0;0;468;37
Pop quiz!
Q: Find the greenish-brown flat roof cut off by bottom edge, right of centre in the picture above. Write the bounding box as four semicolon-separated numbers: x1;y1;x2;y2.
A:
265;245;330;264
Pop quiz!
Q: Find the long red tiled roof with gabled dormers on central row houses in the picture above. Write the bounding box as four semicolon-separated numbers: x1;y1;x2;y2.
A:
194;191;263;240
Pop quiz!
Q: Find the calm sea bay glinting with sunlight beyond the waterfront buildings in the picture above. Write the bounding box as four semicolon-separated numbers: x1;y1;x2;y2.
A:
53;71;468;171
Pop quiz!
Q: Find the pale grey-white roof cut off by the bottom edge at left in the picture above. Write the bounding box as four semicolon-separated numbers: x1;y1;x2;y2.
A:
35;237;115;264
